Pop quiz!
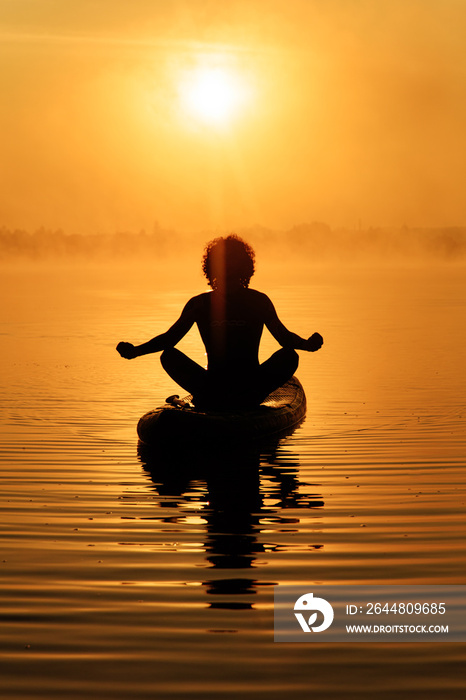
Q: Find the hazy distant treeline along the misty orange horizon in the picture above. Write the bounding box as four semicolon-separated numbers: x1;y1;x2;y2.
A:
0;222;466;261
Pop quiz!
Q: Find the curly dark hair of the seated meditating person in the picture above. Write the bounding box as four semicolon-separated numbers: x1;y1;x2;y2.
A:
202;233;255;289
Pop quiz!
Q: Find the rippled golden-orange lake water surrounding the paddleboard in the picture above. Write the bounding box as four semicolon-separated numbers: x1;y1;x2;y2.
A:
0;262;466;700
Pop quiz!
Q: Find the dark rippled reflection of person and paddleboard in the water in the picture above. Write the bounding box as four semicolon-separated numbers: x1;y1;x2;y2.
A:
138;439;324;609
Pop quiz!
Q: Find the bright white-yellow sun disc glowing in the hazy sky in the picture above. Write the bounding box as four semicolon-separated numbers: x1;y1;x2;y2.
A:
179;66;250;127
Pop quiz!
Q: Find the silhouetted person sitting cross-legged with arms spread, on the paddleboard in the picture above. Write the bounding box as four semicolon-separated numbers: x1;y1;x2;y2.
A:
117;235;324;410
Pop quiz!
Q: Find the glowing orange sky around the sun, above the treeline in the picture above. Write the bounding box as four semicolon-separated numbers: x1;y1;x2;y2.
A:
0;0;466;233
